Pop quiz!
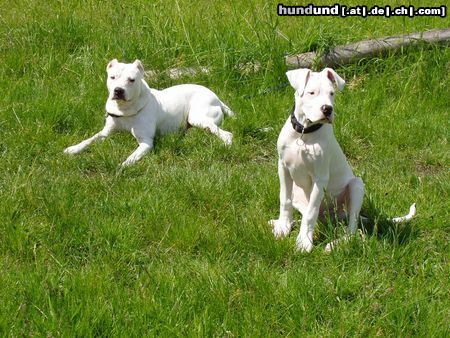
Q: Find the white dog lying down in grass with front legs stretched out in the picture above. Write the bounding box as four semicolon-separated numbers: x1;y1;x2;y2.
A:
64;59;233;166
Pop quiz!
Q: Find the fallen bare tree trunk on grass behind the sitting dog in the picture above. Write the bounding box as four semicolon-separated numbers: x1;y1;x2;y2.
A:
285;28;450;69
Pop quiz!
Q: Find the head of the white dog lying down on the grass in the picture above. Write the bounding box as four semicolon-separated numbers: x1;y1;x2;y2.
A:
106;59;144;102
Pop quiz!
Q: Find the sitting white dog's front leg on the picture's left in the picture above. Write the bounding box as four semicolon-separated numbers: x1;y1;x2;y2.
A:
270;160;294;238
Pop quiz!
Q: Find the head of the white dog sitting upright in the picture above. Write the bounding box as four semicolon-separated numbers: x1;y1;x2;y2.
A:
286;68;345;127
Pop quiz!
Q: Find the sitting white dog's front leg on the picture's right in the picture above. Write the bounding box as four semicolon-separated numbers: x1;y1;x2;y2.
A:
297;182;326;252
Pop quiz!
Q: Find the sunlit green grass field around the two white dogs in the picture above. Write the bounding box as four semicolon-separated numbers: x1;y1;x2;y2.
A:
0;0;450;337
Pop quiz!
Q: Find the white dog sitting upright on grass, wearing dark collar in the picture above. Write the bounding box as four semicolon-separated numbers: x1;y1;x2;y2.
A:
270;68;415;252
